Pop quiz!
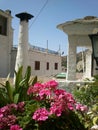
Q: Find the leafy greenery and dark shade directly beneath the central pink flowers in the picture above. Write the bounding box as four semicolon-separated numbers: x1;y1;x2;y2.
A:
18;100;88;130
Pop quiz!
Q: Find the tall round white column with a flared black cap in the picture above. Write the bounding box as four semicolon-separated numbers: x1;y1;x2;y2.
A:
15;12;33;74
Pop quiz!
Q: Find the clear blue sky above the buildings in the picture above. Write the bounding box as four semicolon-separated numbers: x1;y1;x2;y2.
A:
0;0;98;55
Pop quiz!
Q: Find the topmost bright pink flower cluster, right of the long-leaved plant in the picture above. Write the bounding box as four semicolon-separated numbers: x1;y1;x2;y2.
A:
27;80;58;100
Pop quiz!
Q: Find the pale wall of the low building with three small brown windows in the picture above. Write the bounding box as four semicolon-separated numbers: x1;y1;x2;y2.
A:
29;50;61;76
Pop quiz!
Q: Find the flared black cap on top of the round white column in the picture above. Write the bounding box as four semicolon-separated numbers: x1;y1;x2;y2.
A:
15;12;34;22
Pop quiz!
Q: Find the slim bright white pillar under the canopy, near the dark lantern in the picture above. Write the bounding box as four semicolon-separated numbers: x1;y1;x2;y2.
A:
83;50;92;79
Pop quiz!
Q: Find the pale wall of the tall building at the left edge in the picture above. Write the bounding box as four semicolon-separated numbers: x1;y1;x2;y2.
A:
0;11;13;77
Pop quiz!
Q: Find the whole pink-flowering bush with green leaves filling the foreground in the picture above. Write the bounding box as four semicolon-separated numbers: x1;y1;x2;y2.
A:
0;80;87;130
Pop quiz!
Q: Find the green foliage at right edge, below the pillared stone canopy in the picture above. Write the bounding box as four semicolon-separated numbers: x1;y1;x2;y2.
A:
73;79;98;107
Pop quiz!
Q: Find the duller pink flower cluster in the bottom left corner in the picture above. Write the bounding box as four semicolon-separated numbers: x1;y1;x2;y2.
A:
0;102;24;130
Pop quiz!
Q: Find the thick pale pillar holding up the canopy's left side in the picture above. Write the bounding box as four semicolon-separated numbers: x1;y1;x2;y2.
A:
67;36;76;81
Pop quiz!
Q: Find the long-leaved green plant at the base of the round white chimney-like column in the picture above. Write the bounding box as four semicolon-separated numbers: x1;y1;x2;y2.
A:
0;66;37;107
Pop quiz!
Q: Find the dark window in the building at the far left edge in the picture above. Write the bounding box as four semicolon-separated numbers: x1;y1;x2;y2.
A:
0;15;7;35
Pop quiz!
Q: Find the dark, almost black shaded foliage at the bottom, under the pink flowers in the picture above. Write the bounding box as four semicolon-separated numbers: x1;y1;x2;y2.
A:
39;111;87;130
